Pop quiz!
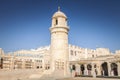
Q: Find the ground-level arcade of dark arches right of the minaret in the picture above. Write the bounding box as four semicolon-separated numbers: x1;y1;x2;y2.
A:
70;61;120;76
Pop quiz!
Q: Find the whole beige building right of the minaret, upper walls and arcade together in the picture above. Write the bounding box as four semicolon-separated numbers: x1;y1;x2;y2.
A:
69;46;120;76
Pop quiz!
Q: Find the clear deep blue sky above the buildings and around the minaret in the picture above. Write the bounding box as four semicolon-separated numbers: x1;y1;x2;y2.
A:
0;0;120;52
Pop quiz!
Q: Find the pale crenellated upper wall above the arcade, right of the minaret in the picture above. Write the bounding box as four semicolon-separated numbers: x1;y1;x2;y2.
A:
69;45;112;61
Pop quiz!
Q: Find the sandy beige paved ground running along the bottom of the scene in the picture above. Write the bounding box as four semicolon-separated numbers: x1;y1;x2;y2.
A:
0;69;120;80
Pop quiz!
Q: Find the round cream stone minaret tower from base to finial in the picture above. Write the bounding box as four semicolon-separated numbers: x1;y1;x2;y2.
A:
50;7;69;77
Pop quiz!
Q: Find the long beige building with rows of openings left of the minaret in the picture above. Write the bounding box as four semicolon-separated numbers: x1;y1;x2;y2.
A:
2;46;50;69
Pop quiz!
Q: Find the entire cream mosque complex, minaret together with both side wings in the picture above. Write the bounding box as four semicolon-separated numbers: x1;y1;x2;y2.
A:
0;8;120;77
